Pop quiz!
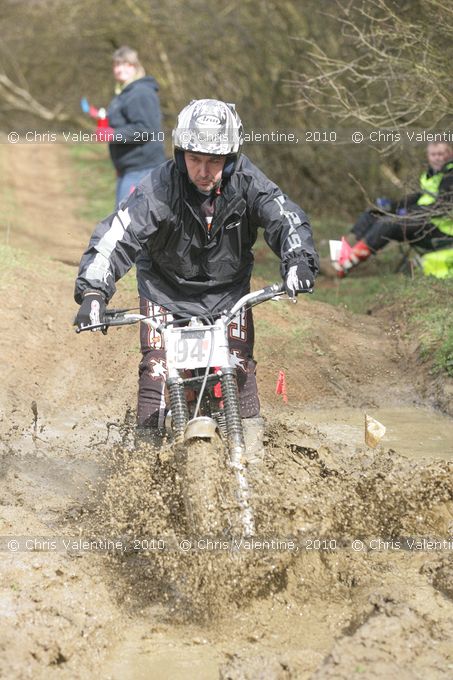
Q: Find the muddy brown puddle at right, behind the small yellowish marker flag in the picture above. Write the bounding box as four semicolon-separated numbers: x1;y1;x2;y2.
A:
303;407;453;460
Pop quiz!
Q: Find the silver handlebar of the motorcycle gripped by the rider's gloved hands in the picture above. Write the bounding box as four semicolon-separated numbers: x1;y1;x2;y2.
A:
76;281;311;333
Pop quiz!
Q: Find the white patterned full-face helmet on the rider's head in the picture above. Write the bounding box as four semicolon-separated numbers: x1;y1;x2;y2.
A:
173;99;243;179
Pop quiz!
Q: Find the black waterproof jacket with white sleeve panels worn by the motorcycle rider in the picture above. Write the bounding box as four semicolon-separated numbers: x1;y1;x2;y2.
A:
75;156;318;314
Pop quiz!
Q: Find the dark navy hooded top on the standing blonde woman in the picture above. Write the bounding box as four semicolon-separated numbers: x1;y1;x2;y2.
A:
107;76;165;175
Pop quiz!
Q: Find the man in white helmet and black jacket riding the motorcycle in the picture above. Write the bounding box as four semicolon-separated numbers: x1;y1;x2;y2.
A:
75;99;318;446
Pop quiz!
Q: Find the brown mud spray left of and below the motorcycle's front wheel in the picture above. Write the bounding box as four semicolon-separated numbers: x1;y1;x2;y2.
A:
81;432;287;623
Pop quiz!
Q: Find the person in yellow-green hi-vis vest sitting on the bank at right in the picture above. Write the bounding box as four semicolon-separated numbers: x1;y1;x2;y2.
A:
334;142;453;278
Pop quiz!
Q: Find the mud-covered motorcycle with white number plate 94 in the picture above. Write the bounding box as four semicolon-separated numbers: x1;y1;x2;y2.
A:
77;283;285;536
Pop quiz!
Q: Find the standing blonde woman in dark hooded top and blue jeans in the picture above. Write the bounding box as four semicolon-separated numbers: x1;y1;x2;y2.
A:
107;46;166;206
